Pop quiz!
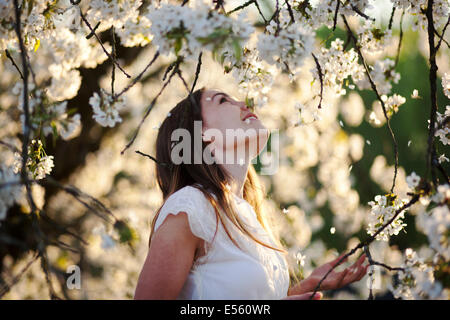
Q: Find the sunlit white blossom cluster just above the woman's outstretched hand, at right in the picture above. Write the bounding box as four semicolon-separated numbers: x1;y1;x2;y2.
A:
367;193;407;241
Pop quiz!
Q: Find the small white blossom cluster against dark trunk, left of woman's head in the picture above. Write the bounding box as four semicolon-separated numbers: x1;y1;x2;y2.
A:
89;89;126;127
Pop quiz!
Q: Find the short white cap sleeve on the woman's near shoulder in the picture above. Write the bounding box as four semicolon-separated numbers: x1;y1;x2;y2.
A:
155;186;216;243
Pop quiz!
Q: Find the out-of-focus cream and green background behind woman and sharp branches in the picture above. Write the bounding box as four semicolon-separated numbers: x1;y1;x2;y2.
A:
0;1;450;299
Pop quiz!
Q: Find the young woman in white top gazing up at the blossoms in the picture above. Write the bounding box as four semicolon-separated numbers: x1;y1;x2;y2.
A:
135;87;368;300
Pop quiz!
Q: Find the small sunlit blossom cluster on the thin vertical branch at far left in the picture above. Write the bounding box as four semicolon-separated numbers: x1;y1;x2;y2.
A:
14;140;54;180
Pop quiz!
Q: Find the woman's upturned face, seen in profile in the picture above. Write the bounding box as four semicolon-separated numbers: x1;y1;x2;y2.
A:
201;90;269;160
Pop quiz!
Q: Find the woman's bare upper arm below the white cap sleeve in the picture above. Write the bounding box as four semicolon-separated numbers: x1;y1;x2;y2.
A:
134;212;201;299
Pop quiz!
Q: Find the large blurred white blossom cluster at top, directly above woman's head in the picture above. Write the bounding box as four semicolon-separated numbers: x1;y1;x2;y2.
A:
146;0;254;60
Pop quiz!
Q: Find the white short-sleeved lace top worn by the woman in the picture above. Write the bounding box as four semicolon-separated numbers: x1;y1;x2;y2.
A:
155;186;289;300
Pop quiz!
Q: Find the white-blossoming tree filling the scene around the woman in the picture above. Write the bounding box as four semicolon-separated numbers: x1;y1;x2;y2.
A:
0;0;450;299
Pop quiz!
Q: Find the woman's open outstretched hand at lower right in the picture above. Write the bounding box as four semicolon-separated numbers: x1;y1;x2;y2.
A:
302;254;369;291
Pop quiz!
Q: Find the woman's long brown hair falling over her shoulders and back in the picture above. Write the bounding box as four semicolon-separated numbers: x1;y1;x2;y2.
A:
149;87;287;253
